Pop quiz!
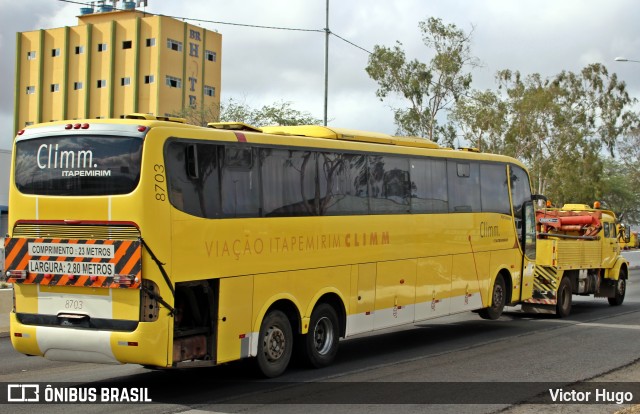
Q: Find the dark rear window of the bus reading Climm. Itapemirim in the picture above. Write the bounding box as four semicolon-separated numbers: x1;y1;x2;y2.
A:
14;135;142;196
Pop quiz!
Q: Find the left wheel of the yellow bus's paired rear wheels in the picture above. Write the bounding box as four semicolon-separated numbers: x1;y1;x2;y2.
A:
257;310;293;378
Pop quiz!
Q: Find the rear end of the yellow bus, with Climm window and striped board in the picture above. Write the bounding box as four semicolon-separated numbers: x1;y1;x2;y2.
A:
5;120;170;366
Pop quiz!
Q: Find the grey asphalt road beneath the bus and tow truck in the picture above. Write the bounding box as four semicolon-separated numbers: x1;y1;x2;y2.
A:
0;270;640;414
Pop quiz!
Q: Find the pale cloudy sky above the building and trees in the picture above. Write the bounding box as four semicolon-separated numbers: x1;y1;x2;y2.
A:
0;0;640;149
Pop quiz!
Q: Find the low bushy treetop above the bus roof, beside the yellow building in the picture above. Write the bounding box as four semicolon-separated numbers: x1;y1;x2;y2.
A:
175;98;321;127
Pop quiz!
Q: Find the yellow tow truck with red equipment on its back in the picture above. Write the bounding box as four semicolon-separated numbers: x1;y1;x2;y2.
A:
522;202;629;317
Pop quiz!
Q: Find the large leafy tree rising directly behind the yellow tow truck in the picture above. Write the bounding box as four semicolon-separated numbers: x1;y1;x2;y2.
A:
488;64;637;202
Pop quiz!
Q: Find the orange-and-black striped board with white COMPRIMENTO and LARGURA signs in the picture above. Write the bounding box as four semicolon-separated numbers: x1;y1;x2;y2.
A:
5;238;142;288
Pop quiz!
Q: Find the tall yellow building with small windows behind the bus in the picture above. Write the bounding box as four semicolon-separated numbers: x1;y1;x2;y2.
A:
14;2;222;132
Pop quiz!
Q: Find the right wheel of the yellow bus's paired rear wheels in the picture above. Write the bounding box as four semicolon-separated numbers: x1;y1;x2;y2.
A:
304;303;340;368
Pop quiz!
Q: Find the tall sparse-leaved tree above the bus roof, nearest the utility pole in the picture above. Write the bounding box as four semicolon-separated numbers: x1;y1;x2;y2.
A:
366;17;479;142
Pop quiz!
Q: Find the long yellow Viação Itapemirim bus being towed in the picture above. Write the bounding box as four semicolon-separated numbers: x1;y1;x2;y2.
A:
5;114;535;377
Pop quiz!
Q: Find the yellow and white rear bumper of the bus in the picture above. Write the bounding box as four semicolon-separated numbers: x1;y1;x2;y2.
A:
10;312;168;367
